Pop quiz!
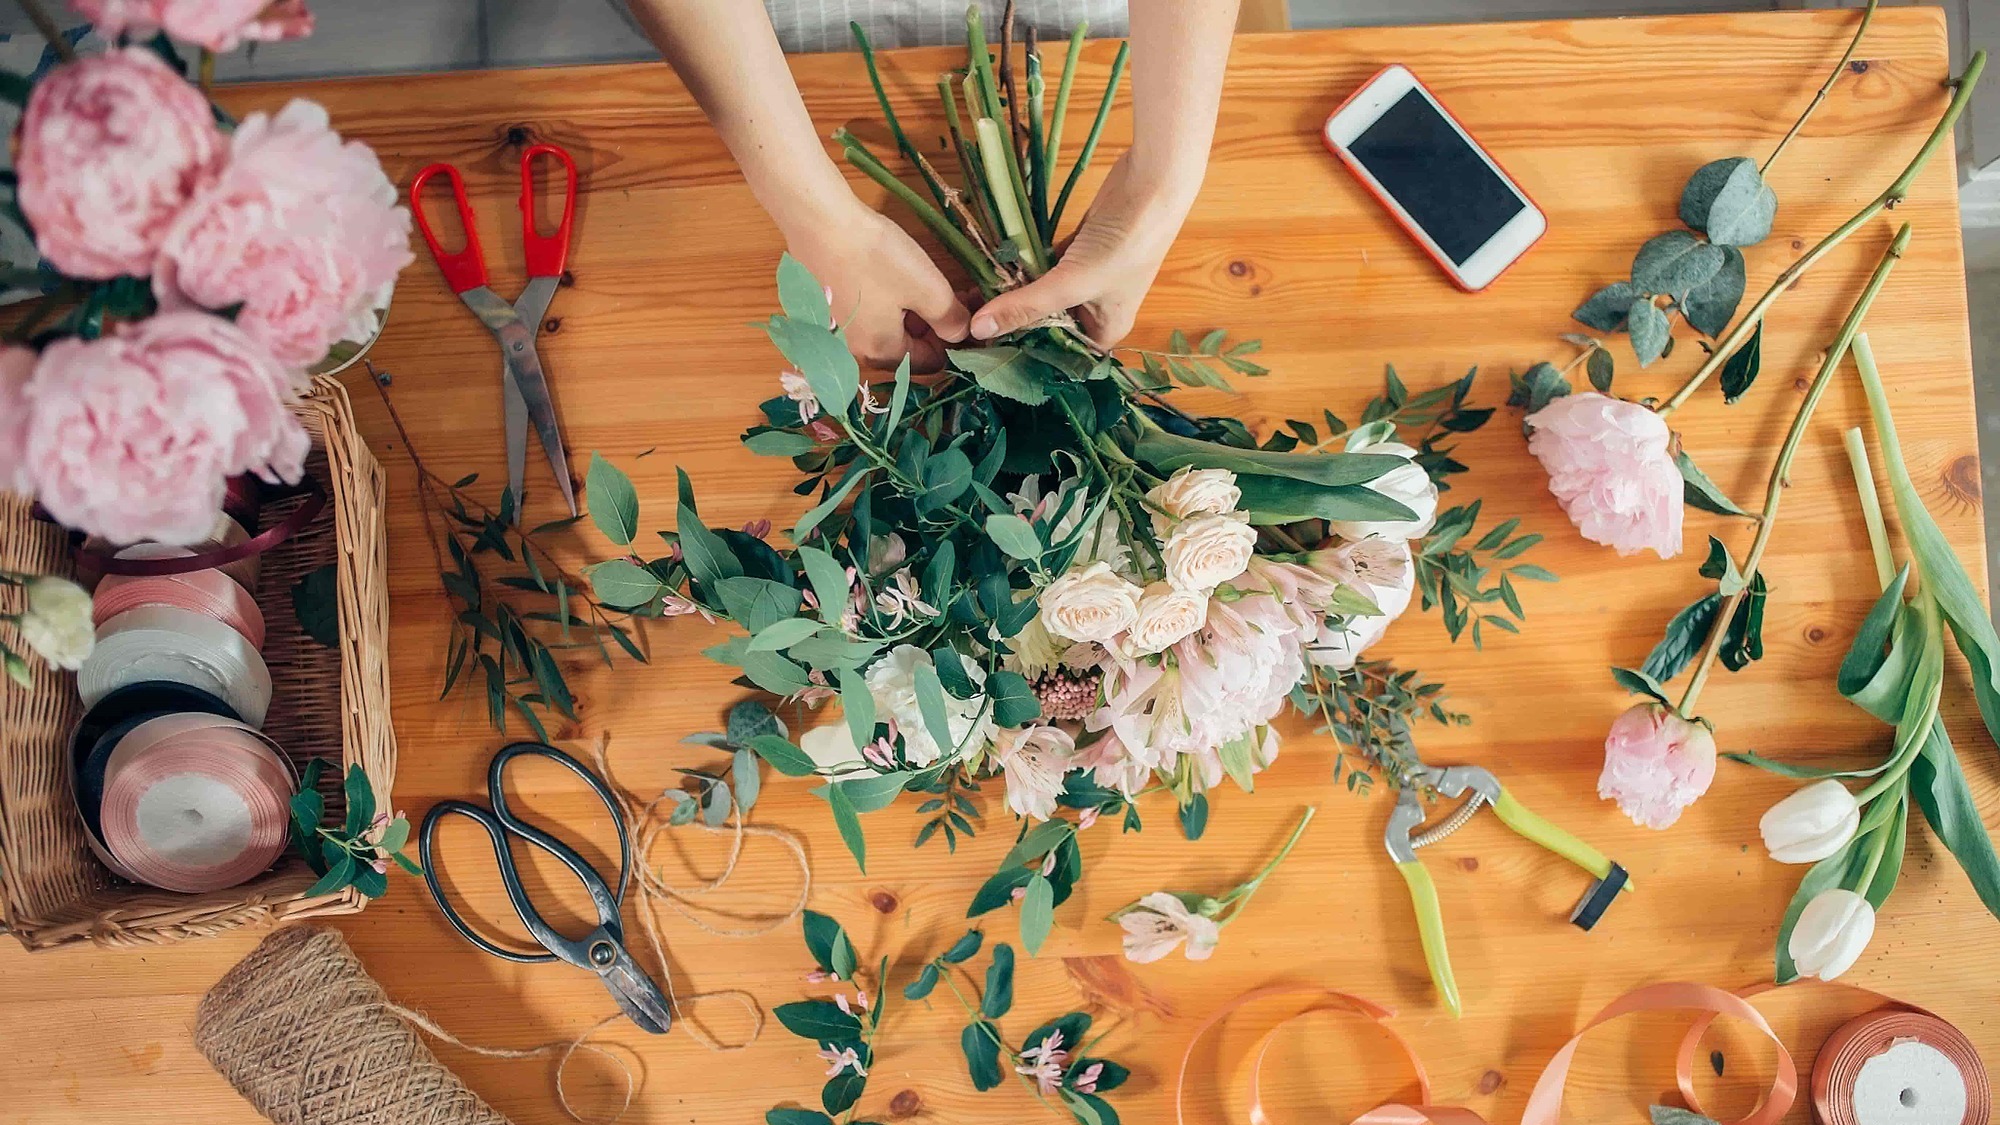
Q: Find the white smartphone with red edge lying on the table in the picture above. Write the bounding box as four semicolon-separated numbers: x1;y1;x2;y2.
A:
1326;66;1548;290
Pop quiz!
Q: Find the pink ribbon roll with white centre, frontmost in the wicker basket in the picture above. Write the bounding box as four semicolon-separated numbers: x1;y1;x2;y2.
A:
102;715;294;893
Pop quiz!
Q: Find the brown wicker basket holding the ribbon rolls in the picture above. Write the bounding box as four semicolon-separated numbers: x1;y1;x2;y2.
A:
0;376;396;949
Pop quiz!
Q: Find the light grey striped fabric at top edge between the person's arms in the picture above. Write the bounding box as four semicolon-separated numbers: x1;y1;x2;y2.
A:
764;0;1126;52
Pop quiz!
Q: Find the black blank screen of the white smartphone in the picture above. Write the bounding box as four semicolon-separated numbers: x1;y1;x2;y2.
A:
1348;90;1528;266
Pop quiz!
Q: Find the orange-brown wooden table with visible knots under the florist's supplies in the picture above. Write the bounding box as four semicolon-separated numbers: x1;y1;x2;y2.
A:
0;8;2000;1125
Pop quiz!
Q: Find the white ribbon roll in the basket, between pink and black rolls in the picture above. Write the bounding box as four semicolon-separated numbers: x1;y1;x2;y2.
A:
76;607;272;727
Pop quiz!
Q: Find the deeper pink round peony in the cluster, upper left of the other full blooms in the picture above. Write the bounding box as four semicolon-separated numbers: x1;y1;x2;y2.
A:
16;48;222;278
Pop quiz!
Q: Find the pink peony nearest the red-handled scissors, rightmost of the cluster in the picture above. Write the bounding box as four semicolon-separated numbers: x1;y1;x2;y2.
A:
152;102;410;368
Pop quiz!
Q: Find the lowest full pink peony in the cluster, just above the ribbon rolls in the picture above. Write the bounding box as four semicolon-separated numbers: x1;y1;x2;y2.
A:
22;312;308;544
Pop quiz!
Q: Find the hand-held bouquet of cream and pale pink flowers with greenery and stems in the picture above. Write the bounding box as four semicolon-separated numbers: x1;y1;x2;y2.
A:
588;8;1550;953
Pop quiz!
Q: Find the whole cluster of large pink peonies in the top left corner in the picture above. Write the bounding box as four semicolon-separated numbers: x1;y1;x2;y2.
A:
0;0;410;544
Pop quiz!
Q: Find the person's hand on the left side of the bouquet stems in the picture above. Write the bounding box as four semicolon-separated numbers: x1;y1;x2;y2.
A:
784;194;970;372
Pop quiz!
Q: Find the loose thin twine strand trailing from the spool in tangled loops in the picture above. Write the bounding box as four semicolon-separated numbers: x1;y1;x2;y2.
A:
304;733;812;1125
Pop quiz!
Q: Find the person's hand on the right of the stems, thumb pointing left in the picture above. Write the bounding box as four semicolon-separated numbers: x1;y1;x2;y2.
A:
972;152;1194;348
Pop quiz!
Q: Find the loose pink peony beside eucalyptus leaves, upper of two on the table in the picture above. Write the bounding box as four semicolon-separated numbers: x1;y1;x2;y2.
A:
1528;390;1682;558
